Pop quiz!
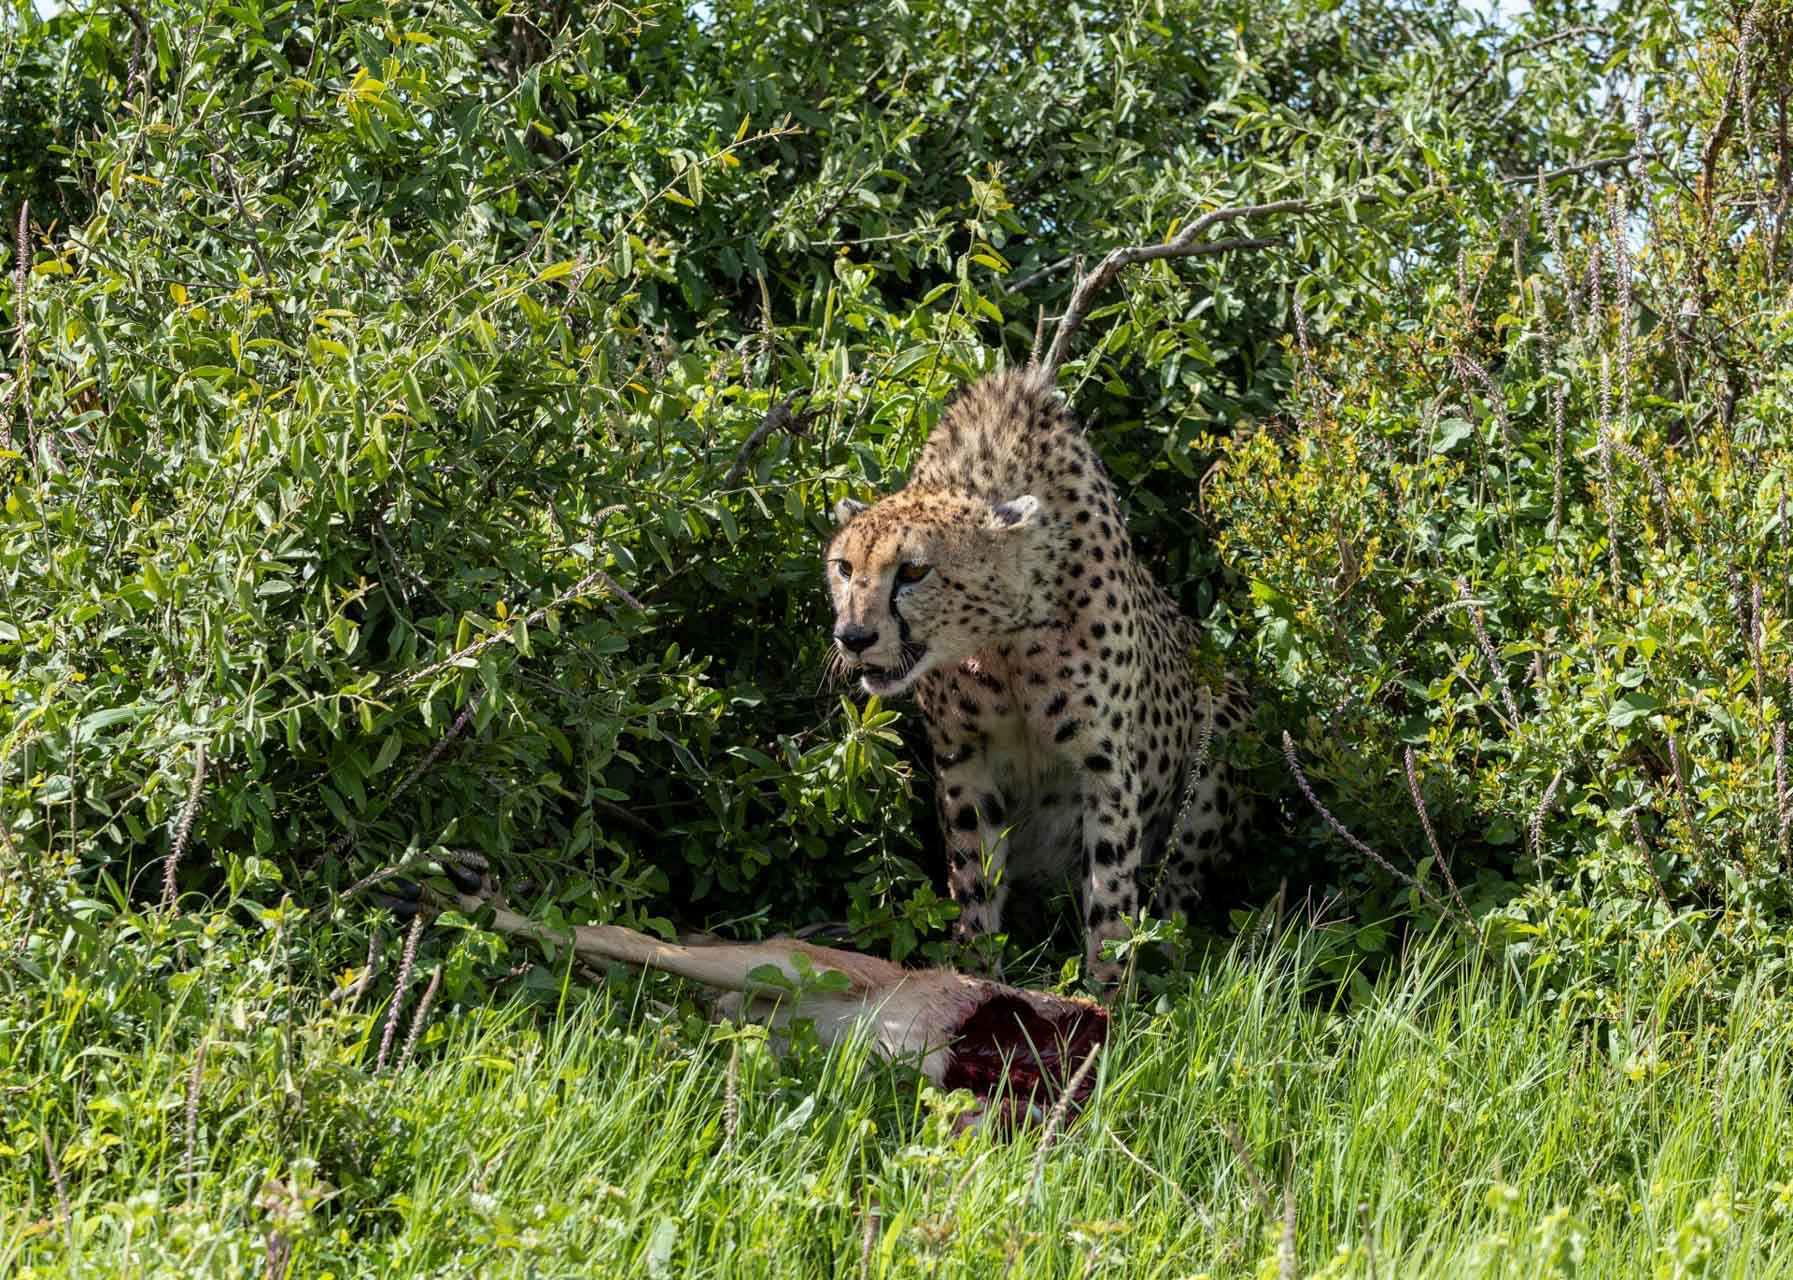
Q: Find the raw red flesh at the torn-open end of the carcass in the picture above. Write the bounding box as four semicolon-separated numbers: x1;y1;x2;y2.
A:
941;991;1108;1113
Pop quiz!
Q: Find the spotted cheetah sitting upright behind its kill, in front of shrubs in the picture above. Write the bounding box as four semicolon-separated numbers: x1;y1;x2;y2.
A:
825;368;1248;988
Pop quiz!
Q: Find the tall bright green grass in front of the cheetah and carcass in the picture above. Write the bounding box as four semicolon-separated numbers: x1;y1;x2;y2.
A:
0;889;1793;1278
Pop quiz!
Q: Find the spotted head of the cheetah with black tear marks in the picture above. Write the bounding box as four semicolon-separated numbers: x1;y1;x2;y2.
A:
825;489;1044;697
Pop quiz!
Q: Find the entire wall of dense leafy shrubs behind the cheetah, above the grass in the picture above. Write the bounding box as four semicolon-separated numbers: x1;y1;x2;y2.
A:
0;0;1793;996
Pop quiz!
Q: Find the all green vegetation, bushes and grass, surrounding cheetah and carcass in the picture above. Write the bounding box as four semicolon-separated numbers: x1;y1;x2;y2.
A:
10;0;1793;1280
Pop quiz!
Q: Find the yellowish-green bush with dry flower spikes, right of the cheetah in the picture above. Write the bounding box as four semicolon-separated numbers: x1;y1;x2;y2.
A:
1212;5;1793;1013
